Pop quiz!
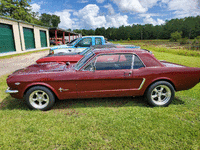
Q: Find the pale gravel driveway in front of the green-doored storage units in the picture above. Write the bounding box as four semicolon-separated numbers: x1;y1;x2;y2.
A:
0;51;49;76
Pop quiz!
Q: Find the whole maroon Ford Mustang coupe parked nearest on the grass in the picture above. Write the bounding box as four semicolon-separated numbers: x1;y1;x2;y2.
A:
6;48;200;110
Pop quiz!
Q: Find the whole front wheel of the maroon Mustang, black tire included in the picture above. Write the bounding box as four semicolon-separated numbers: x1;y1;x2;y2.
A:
25;86;55;111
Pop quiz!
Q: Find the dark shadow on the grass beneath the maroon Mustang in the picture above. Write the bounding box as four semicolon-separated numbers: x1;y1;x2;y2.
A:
0;96;184;110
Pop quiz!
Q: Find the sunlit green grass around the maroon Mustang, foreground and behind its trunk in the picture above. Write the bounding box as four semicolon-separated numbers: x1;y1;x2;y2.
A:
0;42;200;150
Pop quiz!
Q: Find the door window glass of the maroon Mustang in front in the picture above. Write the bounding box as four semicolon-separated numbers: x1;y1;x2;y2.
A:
94;54;133;70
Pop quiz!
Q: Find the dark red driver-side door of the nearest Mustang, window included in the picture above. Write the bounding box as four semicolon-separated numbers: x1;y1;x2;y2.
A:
77;54;144;98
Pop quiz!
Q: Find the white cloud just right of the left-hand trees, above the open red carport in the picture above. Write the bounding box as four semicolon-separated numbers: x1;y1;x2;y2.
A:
54;9;76;29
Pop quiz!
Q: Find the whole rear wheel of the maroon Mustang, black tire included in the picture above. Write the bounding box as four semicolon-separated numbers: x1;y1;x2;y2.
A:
145;81;175;107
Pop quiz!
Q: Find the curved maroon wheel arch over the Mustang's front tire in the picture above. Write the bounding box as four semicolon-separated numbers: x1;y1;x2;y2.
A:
23;83;59;99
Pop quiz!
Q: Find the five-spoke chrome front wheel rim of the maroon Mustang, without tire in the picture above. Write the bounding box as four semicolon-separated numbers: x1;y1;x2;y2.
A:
29;90;49;109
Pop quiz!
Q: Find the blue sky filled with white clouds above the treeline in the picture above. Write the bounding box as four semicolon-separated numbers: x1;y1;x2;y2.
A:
30;0;200;30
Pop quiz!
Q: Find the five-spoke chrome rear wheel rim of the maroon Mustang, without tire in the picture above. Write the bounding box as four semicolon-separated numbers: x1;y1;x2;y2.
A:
151;85;172;106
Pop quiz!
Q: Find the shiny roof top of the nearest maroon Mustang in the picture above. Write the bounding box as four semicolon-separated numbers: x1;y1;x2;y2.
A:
93;47;150;54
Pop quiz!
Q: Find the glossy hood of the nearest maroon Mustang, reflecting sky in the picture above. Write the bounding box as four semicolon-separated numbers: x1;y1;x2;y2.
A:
12;63;71;75
